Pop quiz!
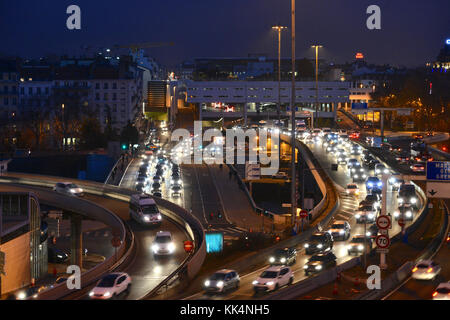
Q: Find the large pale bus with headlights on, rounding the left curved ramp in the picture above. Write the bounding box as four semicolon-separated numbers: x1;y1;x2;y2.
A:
130;193;162;226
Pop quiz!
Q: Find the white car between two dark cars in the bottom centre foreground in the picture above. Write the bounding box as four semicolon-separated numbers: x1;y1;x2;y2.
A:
252;266;294;293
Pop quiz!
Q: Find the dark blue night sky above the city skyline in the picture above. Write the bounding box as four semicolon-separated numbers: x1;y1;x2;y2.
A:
0;0;450;66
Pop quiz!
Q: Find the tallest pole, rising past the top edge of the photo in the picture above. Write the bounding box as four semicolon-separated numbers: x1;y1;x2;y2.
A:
291;0;297;225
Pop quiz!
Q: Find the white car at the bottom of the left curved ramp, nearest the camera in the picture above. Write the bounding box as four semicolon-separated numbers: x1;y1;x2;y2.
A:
89;272;131;300
